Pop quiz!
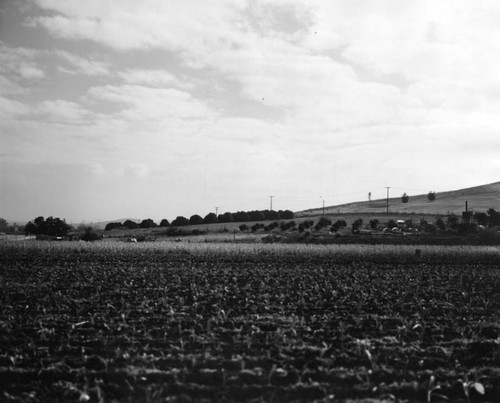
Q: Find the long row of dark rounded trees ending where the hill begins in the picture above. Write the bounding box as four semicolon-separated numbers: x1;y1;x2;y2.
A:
105;210;294;231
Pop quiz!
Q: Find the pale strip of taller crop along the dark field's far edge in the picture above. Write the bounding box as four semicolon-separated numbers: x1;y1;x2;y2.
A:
0;241;500;265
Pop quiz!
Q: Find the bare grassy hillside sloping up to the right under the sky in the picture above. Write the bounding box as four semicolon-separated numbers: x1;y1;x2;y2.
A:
296;182;500;216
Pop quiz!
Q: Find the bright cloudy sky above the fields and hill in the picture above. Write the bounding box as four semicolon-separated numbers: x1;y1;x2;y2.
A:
0;0;500;222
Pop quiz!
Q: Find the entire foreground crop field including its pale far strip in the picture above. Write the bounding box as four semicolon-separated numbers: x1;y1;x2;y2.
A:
0;241;500;402
